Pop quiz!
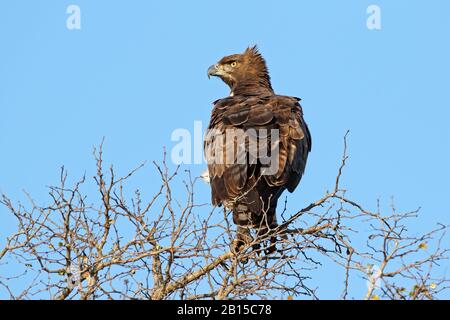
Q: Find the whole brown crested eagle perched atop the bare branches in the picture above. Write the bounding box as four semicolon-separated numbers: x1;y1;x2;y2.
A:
204;45;311;252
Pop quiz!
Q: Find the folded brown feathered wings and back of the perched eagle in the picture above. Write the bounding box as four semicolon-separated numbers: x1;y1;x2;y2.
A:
204;95;311;211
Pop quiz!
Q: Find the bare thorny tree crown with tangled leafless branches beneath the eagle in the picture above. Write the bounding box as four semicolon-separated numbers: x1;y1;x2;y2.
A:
0;137;449;299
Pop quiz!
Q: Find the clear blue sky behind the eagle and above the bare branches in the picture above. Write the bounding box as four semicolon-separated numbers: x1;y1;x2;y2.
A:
0;0;450;296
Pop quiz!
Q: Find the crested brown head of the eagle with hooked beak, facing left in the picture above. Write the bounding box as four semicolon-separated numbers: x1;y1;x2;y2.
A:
208;46;273;95
